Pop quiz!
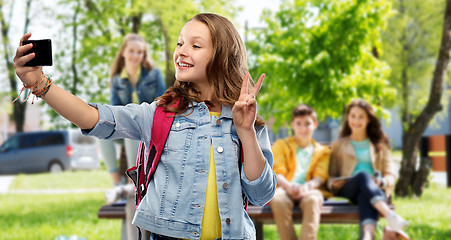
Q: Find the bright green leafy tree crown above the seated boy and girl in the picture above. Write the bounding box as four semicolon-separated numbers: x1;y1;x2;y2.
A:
248;0;395;126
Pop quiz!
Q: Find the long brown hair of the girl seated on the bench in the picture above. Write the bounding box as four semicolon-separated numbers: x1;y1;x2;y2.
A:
340;99;390;149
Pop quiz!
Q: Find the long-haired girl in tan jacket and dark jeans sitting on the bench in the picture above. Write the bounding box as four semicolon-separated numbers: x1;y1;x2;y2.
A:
328;99;408;240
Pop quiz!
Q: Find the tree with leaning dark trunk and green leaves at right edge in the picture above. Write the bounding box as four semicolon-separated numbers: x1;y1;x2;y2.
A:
393;0;451;197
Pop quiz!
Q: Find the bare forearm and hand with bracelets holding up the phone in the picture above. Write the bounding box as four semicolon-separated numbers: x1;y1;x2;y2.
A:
14;33;99;129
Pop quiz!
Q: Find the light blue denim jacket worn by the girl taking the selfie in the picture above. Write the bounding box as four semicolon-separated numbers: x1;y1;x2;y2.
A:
83;102;276;239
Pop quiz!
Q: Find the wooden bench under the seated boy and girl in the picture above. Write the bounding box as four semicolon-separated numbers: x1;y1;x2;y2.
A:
97;200;394;240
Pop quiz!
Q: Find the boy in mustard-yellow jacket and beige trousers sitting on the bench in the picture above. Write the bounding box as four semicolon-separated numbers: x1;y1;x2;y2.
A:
271;104;331;240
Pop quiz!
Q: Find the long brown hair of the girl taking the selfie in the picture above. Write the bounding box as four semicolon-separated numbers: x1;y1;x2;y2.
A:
157;13;265;126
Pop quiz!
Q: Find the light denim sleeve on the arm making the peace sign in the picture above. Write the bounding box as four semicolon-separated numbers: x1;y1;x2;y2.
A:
241;124;277;206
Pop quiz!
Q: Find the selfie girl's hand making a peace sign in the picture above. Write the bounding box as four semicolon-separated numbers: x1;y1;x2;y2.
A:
232;73;265;133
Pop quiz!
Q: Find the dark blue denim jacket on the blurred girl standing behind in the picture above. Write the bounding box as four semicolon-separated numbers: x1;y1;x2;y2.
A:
111;67;166;105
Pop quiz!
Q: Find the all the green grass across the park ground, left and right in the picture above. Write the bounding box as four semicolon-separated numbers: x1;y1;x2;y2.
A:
0;170;451;240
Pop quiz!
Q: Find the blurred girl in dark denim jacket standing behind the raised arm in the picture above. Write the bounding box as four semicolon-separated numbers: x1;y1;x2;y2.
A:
99;33;166;239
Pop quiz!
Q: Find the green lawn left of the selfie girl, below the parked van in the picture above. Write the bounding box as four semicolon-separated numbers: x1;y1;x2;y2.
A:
0;169;121;240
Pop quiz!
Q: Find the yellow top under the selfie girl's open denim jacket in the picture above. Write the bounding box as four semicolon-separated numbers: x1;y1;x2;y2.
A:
200;112;221;240
